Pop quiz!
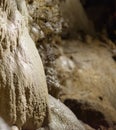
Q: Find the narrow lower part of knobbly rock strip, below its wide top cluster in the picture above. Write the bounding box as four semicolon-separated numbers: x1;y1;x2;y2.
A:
38;43;61;98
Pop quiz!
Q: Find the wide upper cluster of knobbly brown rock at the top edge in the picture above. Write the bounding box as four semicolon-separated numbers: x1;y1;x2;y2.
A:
27;0;62;44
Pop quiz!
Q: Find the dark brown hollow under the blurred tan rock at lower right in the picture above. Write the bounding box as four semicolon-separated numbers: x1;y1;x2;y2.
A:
64;98;110;129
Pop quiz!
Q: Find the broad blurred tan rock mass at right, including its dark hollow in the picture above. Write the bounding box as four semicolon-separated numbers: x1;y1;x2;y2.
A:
56;39;116;129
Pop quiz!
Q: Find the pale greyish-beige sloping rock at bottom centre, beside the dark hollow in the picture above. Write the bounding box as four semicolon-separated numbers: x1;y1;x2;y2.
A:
49;96;85;130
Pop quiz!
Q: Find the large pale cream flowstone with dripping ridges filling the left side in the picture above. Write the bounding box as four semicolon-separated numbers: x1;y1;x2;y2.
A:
0;0;48;128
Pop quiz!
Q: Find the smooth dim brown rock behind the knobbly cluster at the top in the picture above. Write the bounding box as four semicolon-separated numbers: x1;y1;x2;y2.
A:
60;0;95;37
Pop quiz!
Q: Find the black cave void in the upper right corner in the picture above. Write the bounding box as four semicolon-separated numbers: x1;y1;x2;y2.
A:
81;0;116;42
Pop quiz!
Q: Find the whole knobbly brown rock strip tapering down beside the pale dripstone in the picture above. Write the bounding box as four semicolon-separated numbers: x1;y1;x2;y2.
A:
27;0;62;97
